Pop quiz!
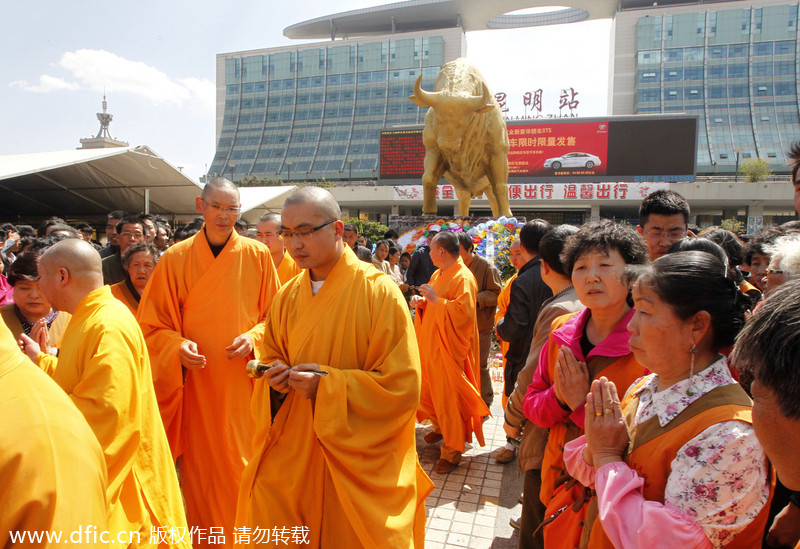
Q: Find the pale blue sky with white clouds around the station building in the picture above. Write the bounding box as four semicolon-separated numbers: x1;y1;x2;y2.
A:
0;0;611;179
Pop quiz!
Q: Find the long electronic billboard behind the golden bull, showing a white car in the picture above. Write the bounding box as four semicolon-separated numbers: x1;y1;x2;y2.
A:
380;115;697;184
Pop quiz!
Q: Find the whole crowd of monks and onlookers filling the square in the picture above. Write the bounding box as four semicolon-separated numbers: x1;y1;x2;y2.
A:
0;143;800;549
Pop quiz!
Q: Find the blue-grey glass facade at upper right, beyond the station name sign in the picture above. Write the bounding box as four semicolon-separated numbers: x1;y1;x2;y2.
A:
634;3;800;173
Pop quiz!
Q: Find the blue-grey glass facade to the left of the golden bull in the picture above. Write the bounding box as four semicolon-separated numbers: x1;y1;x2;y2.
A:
209;35;463;180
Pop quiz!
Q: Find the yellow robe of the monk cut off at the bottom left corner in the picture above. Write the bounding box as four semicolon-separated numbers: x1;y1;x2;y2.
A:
0;322;107;547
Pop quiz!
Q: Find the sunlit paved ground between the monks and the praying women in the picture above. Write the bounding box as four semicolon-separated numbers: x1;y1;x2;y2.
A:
417;370;523;549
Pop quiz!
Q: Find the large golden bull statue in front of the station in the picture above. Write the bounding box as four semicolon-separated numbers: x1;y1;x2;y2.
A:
409;58;512;217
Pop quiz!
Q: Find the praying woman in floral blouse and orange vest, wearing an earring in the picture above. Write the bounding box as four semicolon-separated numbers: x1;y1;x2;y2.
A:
564;251;771;549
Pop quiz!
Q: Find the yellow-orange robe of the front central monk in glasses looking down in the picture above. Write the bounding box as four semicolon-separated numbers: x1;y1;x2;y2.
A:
236;246;433;549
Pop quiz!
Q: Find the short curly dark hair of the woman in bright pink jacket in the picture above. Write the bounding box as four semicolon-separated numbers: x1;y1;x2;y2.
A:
561;219;648;275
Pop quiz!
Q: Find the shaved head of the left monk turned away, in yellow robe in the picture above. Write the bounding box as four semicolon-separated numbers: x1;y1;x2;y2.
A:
39;239;103;313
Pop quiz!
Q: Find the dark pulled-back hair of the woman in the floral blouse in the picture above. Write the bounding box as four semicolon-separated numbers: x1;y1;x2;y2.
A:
634;250;750;351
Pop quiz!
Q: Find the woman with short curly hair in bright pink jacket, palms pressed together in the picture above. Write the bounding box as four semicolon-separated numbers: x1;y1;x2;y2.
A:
523;220;647;549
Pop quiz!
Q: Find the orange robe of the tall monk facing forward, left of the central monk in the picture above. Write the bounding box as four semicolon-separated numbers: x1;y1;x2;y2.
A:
138;230;279;547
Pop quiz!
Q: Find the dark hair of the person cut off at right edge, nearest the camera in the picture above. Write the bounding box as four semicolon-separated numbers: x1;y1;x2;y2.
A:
731;280;800;419
